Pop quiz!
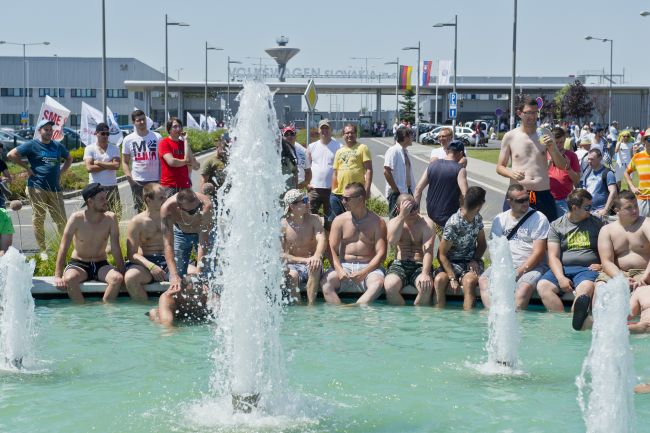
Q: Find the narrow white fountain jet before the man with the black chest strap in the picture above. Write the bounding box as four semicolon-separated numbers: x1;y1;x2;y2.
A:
485;236;520;368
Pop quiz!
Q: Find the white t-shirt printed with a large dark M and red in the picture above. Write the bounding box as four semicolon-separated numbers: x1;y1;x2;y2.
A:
122;131;160;182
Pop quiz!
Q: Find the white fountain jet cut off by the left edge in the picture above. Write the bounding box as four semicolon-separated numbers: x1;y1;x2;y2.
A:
0;247;36;370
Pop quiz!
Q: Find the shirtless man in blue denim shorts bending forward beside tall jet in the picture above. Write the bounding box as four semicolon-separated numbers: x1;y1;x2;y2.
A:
160;188;212;290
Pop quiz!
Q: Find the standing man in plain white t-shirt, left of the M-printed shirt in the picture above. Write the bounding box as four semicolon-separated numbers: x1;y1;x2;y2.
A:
84;122;122;219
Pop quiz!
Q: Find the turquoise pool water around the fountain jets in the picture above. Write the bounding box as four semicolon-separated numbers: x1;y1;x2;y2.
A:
0;300;650;433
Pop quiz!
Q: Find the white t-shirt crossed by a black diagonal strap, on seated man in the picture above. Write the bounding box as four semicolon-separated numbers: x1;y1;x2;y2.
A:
490;210;549;268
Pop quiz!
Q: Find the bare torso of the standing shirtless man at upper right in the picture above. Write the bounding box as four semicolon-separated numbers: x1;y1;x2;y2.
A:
499;128;550;191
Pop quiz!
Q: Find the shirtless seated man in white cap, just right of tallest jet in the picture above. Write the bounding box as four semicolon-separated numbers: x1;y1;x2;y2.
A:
281;189;327;305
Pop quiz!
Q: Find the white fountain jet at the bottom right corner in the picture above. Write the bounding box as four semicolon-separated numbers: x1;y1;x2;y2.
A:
576;274;635;433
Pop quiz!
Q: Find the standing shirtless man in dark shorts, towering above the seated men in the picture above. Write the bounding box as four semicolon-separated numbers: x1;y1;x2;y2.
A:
497;96;569;223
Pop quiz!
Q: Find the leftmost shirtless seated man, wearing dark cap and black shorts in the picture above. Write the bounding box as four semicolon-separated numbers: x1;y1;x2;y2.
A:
54;183;124;303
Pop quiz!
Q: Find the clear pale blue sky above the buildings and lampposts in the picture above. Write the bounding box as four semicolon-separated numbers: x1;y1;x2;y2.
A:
0;0;650;111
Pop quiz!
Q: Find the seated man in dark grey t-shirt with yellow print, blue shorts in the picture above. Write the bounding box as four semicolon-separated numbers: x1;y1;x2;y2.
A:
537;188;603;331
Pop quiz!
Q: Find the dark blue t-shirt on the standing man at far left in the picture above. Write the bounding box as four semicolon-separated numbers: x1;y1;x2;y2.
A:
16;140;70;191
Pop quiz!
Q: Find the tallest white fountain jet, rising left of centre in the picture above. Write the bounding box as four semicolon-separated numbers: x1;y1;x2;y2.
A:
211;82;285;412
